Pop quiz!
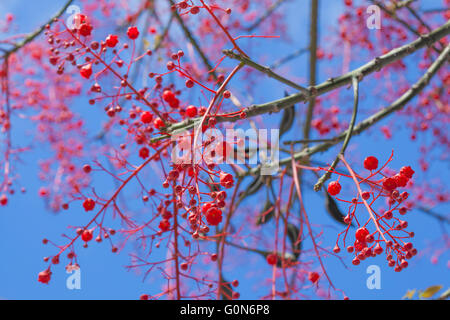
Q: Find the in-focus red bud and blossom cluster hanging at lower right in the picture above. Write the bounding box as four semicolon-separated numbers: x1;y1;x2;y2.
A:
328;155;417;271
